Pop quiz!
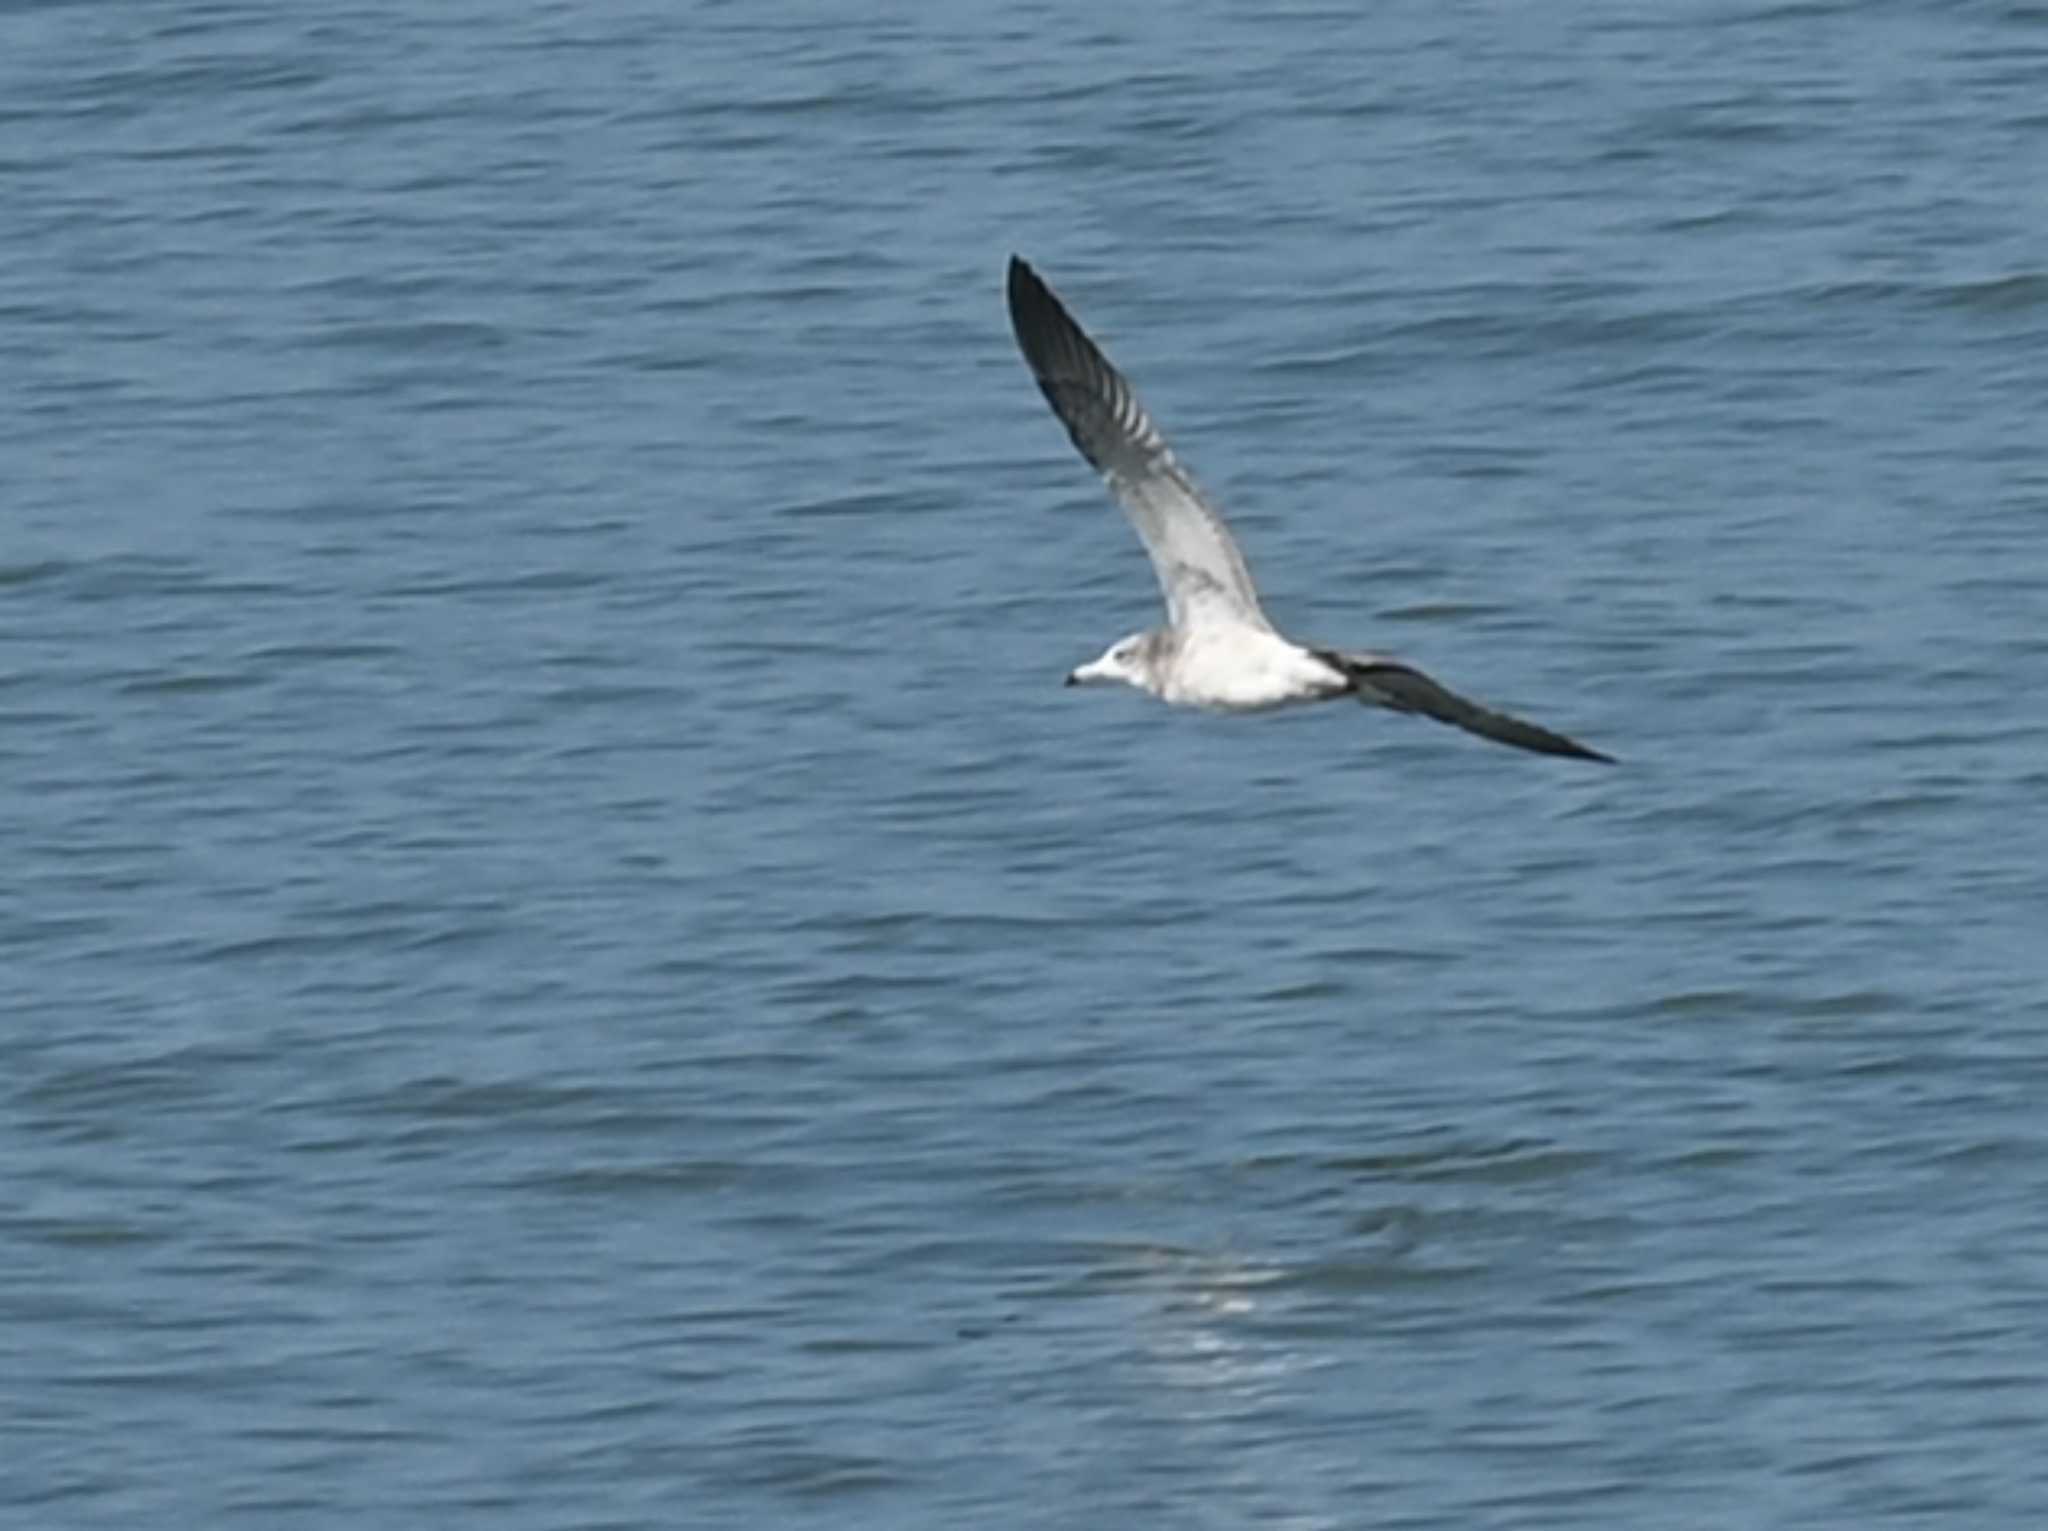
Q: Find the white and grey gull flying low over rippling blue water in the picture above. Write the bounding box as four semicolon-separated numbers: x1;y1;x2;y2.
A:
1010;256;1614;777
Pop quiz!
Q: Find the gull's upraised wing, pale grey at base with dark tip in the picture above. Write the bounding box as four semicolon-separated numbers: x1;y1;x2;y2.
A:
1010;256;1272;632
